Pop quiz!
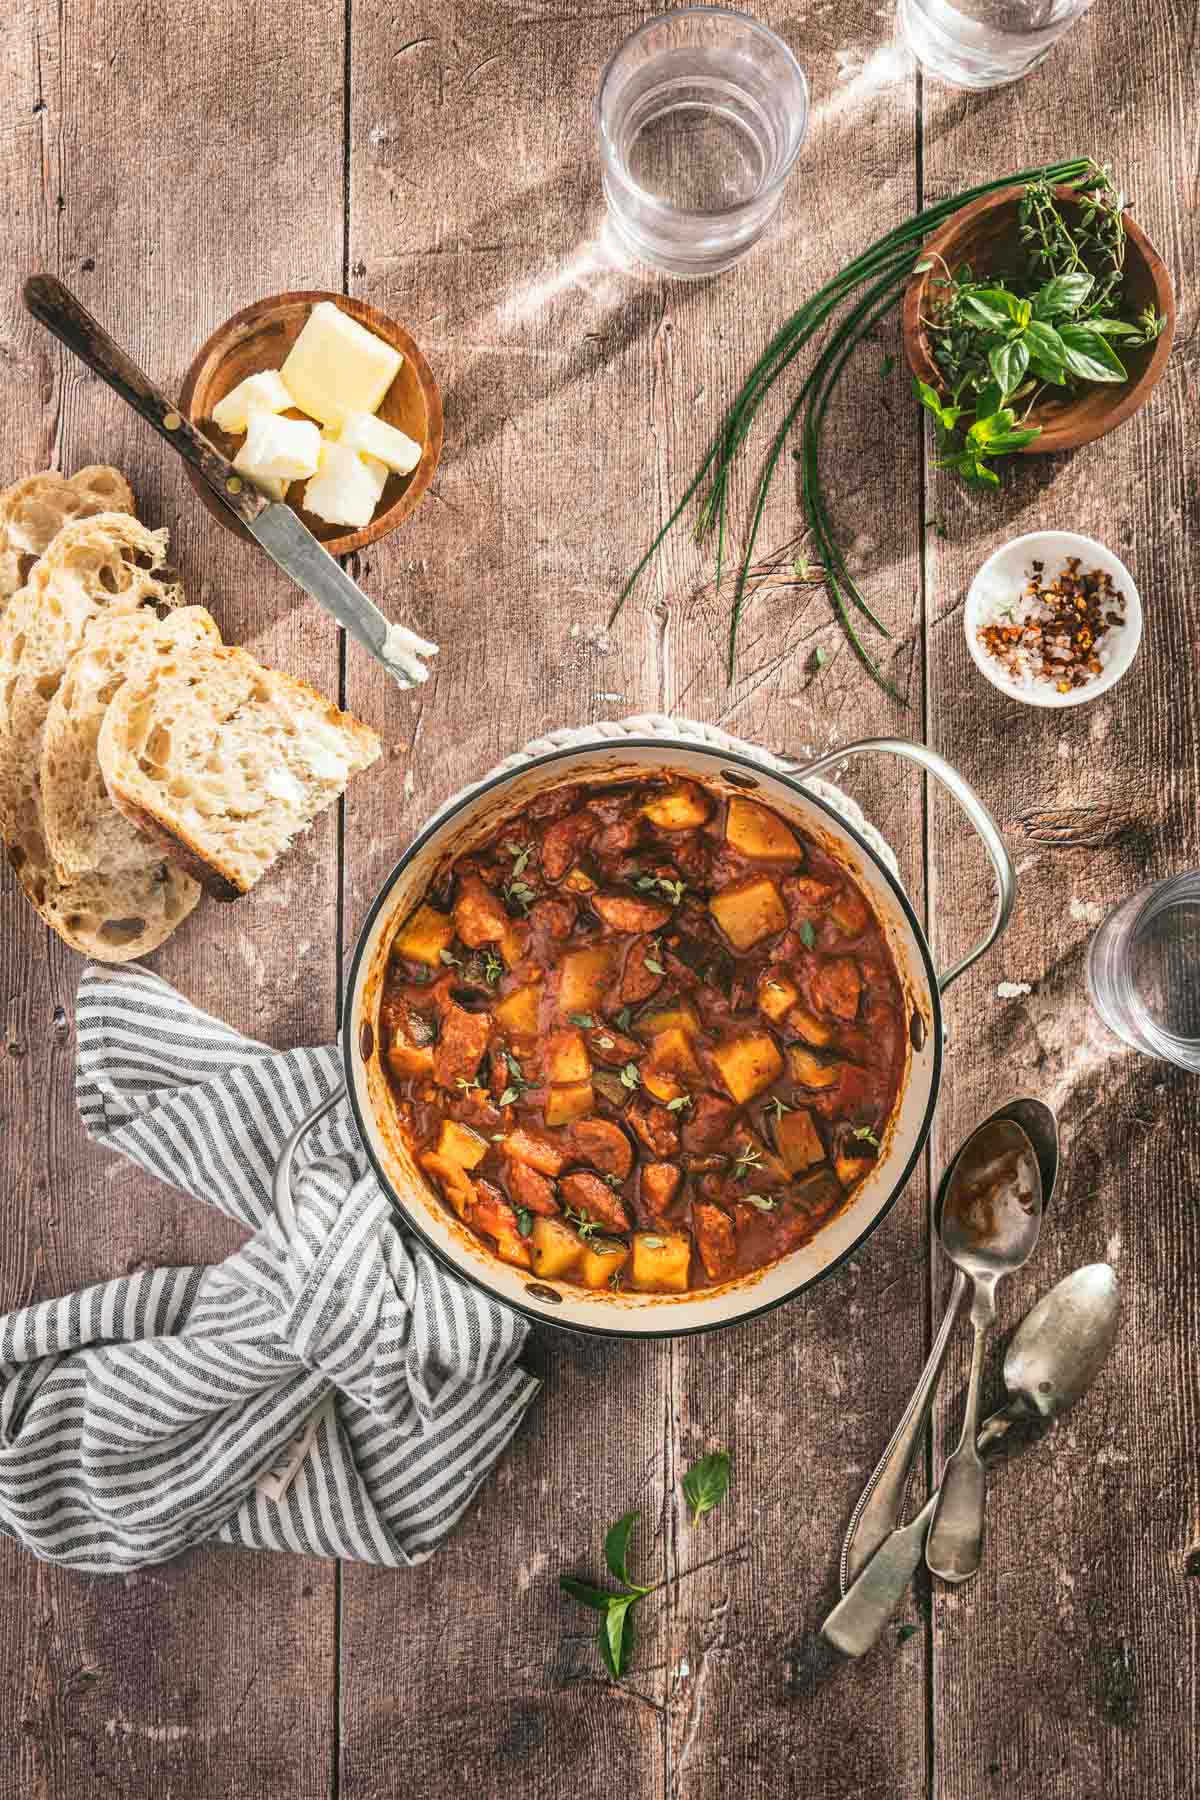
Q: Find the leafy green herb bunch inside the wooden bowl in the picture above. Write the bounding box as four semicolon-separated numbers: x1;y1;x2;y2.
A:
914;171;1164;488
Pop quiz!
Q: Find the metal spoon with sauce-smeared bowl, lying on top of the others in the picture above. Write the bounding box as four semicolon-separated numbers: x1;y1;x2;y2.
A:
925;1120;1042;1582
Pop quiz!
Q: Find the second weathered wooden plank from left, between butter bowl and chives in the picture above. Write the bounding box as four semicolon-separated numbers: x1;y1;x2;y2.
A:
342;5;667;1800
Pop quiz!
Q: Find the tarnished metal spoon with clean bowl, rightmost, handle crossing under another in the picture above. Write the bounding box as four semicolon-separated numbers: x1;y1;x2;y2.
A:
820;1262;1121;1656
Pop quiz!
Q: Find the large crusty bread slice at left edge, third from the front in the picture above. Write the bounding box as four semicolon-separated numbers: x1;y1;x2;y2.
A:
0;513;200;963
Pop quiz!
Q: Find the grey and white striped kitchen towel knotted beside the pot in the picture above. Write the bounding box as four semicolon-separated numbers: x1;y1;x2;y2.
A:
0;965;538;1571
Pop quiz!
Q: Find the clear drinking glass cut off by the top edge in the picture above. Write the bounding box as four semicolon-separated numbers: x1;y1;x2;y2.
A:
896;0;1092;88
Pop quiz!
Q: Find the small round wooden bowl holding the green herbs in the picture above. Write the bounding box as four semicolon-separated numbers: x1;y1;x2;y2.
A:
901;187;1175;455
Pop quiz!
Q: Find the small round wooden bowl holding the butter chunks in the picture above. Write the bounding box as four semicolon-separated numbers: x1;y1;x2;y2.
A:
180;292;443;556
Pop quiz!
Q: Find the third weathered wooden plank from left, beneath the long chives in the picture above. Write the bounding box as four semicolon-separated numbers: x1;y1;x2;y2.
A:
647;5;928;1800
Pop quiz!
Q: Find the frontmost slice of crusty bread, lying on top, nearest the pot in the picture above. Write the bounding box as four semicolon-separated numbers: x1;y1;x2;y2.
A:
99;644;380;900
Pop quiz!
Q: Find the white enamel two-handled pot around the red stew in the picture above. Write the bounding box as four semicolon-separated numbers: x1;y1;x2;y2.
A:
277;716;1015;1337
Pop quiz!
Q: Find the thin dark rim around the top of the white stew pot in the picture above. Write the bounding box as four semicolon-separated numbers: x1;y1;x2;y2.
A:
342;736;943;1339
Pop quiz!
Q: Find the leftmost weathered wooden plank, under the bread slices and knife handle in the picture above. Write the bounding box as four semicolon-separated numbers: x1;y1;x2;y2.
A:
0;4;342;1800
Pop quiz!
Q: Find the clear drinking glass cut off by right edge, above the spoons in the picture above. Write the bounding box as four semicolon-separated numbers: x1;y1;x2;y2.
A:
1087;869;1200;1073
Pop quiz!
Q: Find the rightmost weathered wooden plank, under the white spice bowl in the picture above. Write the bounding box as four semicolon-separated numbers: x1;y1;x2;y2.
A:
925;4;1200;1800
